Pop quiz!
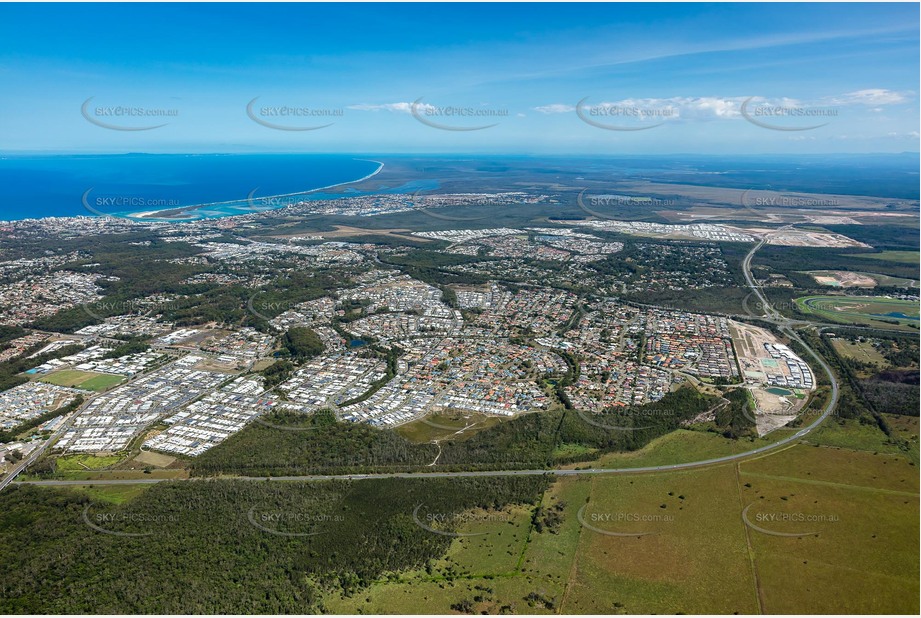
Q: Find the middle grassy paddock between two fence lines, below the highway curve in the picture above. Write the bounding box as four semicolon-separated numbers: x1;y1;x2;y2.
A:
563;465;758;614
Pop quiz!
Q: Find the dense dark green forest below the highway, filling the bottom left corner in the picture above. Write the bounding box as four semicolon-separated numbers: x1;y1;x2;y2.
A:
0;476;548;614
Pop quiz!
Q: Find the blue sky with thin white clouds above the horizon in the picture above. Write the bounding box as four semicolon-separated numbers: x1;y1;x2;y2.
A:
0;4;919;155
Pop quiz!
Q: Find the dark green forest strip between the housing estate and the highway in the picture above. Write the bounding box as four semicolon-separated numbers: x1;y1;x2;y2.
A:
191;387;719;476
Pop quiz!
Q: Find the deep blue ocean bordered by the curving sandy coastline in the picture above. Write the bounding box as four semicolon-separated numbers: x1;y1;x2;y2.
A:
0;154;380;220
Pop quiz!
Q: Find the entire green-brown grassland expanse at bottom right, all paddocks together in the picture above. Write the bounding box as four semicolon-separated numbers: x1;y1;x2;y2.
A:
326;417;919;614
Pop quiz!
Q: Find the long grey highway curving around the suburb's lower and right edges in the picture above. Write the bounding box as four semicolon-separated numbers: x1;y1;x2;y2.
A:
7;235;839;485
